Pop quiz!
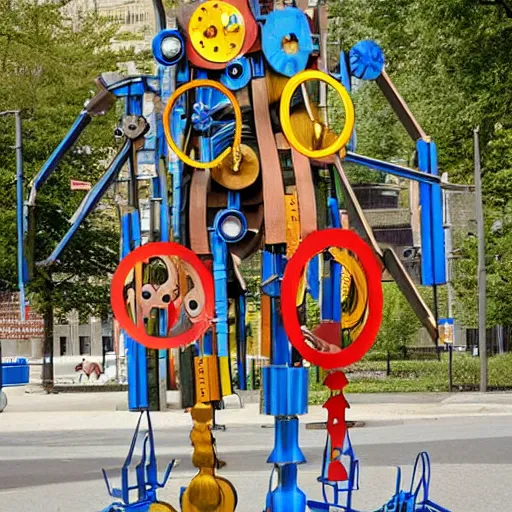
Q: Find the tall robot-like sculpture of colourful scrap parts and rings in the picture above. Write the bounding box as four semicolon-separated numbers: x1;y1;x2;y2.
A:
19;0;460;512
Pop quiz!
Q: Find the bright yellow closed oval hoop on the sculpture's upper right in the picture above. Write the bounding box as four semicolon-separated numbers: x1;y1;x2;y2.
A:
279;69;355;159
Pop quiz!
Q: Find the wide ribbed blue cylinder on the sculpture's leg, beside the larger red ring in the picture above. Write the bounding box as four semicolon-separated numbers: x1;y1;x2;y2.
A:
262;366;308;416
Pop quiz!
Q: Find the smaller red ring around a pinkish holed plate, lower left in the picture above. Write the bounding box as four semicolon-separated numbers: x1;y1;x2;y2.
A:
110;242;215;349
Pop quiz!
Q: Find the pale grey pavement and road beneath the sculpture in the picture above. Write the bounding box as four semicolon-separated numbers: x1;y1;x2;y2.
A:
0;389;512;512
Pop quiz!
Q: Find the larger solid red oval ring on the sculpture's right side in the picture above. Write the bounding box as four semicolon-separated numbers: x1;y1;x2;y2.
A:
281;229;383;369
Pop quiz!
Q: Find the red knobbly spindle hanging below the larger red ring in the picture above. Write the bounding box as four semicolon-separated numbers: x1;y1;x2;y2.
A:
324;370;350;482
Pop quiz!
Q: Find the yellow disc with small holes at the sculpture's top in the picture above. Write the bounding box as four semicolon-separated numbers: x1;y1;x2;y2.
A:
188;0;245;62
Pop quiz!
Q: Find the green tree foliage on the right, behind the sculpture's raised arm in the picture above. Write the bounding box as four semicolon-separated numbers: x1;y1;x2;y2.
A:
330;0;512;325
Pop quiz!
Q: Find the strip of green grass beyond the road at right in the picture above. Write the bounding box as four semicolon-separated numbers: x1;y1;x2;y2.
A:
310;353;512;404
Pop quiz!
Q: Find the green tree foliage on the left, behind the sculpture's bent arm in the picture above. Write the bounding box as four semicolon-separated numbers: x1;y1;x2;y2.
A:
0;0;137;315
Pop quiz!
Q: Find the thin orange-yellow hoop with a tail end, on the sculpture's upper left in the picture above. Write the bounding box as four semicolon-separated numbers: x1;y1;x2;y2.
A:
163;79;242;169
